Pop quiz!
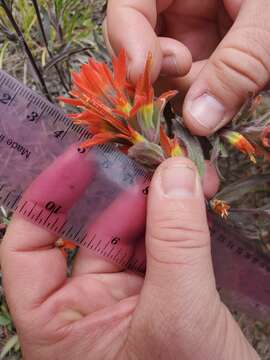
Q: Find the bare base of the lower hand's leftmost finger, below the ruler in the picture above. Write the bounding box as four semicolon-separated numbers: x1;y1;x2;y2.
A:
1;215;66;316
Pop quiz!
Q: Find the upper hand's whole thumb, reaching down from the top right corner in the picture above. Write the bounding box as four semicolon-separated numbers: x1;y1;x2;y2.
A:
183;0;270;136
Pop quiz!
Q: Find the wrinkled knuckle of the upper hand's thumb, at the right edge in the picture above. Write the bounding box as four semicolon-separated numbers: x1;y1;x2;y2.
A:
211;28;270;97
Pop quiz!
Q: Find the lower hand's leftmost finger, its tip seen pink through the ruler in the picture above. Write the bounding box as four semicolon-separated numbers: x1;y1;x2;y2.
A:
1;146;94;311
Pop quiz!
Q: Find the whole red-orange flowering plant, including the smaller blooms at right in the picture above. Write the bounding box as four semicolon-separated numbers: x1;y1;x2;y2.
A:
60;50;270;239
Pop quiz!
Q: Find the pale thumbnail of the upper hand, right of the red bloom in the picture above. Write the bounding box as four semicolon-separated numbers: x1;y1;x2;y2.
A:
188;94;226;130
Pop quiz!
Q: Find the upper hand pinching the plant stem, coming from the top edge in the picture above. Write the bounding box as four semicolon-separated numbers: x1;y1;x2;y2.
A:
104;0;270;136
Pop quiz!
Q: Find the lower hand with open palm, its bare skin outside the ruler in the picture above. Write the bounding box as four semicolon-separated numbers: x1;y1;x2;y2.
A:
1;158;259;360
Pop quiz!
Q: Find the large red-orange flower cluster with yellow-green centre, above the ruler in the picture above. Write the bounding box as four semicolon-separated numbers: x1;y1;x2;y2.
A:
60;50;182;157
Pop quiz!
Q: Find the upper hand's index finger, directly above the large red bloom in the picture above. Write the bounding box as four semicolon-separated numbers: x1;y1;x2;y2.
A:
107;0;163;81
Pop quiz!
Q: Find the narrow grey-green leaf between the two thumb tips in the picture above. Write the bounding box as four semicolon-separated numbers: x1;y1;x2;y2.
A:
173;118;205;177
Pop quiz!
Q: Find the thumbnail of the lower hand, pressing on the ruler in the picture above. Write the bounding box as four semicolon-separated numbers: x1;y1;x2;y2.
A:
161;164;197;198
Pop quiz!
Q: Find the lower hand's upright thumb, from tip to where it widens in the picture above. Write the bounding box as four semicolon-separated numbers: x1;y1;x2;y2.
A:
143;158;215;293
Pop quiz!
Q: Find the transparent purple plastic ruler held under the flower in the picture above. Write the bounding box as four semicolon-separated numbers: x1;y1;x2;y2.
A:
0;71;270;319
